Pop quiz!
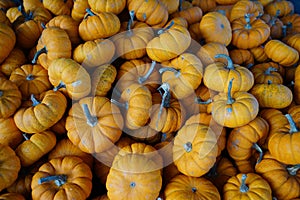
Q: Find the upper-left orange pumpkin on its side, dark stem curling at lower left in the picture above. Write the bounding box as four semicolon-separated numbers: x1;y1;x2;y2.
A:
32;27;72;69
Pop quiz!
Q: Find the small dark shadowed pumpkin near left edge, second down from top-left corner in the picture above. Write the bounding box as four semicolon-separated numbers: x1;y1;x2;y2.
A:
0;47;27;77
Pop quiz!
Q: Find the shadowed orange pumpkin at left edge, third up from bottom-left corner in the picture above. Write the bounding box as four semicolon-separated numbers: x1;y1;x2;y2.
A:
0;117;23;149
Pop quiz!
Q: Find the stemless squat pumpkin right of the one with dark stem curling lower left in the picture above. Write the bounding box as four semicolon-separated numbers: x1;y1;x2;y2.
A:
73;39;115;68
